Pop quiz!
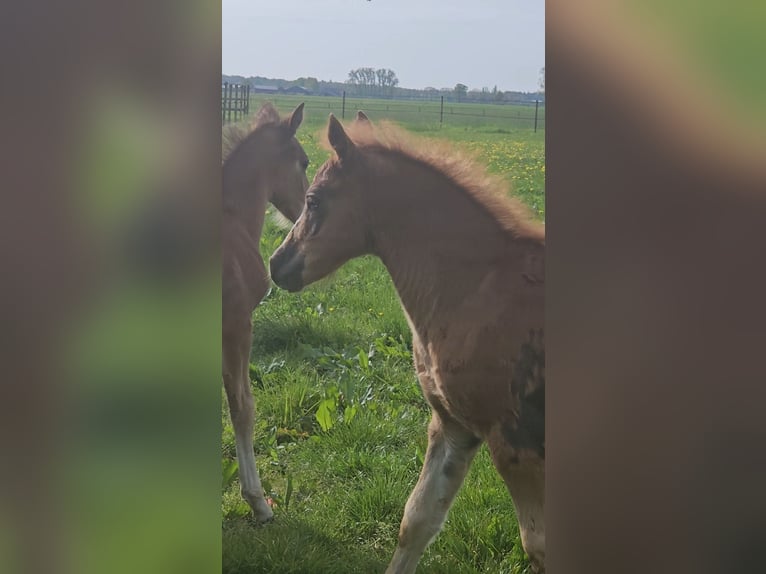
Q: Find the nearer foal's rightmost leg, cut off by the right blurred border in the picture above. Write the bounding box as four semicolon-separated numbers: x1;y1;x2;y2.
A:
488;436;545;574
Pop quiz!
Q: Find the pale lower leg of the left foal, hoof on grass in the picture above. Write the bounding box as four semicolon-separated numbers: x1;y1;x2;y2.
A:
223;319;274;522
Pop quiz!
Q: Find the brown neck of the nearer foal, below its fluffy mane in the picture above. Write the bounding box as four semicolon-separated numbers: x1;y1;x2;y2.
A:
370;160;508;333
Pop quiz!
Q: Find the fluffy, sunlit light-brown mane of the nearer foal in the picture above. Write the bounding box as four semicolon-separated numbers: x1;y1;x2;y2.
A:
325;121;545;242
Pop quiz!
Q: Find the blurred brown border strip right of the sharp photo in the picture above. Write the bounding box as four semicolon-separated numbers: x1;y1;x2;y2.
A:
546;0;766;574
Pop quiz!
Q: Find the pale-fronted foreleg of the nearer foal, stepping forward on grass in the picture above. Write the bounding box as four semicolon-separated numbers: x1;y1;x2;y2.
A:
386;411;481;574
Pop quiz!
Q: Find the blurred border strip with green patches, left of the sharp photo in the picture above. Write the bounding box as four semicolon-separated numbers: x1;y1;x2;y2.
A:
0;0;221;573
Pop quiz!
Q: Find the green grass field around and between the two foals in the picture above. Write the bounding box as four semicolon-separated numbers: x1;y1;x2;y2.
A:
222;97;545;574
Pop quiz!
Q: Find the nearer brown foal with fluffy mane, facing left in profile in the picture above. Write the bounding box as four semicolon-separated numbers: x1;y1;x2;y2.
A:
270;115;545;574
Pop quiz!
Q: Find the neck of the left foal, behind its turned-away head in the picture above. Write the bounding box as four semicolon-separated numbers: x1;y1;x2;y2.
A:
222;137;269;240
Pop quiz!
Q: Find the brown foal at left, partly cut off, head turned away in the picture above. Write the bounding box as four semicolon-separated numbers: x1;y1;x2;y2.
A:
221;104;309;522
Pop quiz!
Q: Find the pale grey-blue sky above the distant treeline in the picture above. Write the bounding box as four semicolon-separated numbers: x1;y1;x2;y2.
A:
222;0;545;92
